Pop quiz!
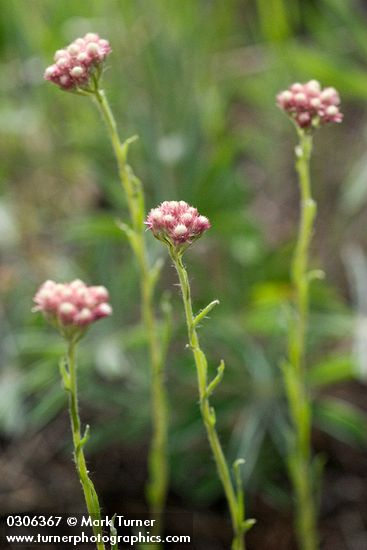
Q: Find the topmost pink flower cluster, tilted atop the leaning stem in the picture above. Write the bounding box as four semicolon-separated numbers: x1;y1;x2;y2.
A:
44;32;111;90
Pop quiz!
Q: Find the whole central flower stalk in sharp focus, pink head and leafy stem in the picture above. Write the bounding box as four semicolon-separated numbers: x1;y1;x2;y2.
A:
145;201;254;550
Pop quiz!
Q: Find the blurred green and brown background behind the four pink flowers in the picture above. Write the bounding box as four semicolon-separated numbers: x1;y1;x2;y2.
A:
0;0;367;550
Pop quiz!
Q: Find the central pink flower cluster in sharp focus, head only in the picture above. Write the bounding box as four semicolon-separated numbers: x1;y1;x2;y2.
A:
145;201;210;246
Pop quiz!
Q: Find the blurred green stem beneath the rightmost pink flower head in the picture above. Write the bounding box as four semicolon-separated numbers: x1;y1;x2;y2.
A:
286;130;318;550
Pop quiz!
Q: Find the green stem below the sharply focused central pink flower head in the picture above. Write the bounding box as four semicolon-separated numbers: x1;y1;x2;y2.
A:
170;248;245;550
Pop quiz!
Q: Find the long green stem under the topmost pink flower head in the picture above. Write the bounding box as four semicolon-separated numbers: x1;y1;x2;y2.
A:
93;85;168;535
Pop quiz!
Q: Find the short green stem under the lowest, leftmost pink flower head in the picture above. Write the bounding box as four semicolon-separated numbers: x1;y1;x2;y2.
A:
64;340;105;550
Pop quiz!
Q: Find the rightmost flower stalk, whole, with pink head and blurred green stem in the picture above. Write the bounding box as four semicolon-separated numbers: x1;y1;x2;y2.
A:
277;80;343;550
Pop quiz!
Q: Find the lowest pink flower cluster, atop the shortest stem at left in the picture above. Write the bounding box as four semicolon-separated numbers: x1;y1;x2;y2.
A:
33;279;112;327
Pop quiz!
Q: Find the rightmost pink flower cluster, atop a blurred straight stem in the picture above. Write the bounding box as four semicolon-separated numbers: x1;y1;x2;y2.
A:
277;80;343;128
